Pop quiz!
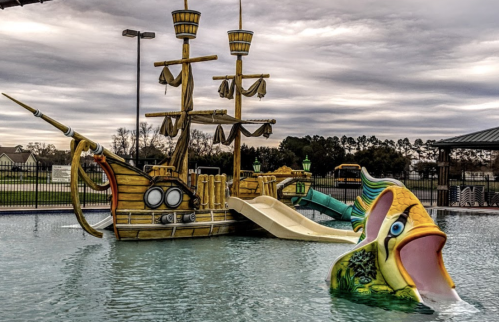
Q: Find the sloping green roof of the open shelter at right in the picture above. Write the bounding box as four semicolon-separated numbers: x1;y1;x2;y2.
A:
433;127;499;150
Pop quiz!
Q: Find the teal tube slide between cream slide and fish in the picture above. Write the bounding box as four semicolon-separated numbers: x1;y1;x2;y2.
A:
291;188;353;221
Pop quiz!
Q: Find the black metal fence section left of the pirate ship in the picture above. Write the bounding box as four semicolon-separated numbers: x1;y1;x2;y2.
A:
0;162;110;208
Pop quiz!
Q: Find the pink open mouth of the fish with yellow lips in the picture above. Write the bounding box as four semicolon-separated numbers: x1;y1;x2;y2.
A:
396;229;460;300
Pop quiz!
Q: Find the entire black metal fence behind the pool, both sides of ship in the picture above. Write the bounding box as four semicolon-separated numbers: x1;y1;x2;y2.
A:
0;162;499;208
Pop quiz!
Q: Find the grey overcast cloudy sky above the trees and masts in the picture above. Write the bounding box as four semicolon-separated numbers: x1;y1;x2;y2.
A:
0;0;499;149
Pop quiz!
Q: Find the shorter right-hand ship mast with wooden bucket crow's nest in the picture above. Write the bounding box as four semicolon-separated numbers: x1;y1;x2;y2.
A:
213;0;270;197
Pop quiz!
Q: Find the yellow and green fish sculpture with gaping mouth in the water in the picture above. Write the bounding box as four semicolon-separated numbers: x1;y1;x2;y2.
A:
327;168;460;302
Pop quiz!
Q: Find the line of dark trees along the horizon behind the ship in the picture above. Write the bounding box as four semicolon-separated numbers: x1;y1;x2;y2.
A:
13;122;499;176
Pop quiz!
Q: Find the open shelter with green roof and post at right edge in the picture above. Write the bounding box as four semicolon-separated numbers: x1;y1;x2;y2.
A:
433;127;499;206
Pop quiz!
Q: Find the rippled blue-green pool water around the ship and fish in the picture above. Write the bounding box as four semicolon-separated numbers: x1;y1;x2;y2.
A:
0;213;499;322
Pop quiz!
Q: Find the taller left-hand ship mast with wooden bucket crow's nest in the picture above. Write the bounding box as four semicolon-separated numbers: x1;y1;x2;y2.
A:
153;0;218;182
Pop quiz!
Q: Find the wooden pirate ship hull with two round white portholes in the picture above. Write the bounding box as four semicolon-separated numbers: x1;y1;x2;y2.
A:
95;156;256;240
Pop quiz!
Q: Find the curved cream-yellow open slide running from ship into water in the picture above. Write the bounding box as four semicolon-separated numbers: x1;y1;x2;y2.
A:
228;196;360;244
